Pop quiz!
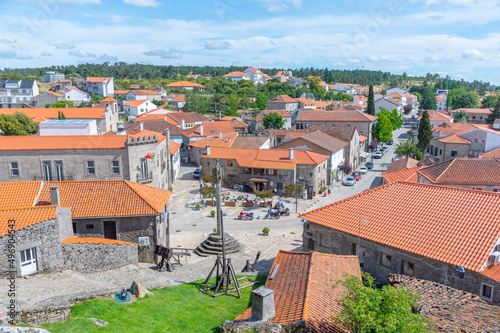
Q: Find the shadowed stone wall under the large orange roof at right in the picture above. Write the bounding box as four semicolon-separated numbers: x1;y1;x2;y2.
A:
303;222;500;302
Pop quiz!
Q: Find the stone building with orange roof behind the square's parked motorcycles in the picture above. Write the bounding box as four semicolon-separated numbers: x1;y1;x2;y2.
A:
201;146;328;198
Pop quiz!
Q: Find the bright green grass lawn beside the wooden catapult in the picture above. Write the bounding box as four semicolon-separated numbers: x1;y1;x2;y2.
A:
41;275;266;333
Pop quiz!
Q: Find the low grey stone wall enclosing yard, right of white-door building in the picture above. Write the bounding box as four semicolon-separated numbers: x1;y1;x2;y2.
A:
62;243;138;272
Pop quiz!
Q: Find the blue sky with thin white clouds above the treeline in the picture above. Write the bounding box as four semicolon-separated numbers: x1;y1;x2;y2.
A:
0;0;500;85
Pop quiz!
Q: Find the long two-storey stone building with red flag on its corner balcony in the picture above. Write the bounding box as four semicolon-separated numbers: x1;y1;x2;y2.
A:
0;130;170;188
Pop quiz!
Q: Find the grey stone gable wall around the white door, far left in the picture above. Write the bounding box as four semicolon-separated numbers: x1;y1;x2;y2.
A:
0;208;73;276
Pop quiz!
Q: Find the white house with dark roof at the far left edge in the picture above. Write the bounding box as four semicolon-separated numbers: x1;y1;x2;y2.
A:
0;80;40;108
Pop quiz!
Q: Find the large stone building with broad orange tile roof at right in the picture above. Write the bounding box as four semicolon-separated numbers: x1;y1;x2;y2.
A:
299;182;500;303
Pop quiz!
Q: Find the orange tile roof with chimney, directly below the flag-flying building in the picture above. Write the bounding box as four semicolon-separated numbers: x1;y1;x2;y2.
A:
0;180;172;218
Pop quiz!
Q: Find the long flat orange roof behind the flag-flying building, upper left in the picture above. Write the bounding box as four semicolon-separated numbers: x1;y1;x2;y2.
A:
0;108;106;119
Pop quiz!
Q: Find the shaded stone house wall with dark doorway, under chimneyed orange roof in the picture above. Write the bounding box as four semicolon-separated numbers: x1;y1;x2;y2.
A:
73;215;160;263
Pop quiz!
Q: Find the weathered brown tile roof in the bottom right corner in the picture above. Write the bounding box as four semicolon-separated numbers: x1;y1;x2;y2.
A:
388;274;500;332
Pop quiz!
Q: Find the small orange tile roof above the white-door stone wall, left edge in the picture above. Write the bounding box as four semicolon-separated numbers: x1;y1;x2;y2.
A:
0;206;57;236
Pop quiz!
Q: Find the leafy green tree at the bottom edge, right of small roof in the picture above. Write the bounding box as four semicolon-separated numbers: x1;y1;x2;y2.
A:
333;273;429;333
